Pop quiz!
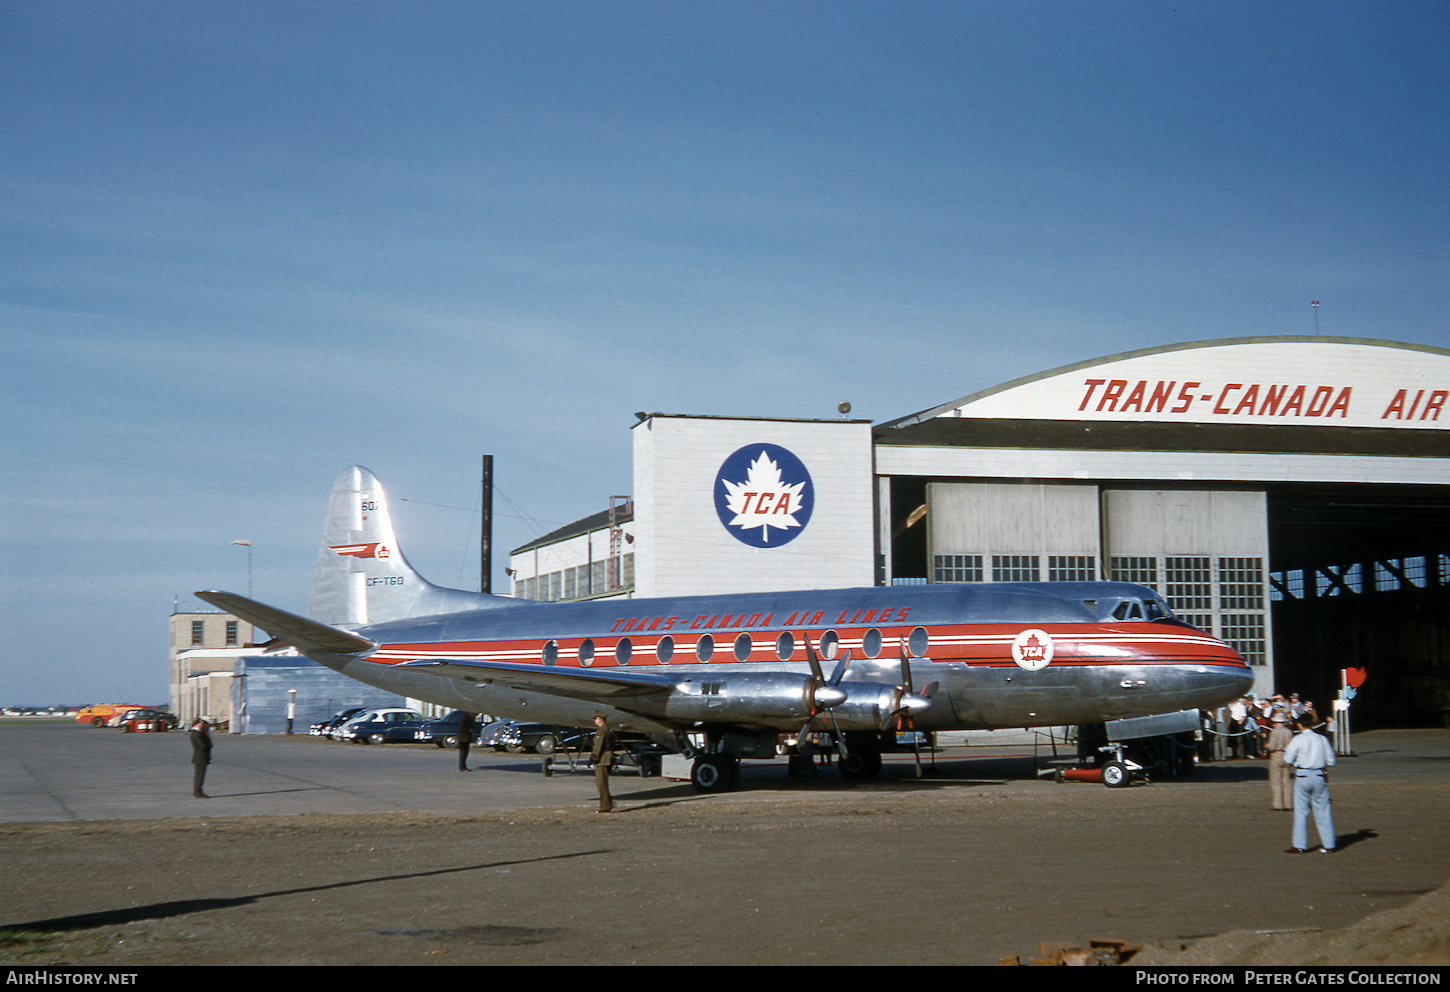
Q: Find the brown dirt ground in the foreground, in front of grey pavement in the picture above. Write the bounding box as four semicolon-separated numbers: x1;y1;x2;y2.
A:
8;782;1450;966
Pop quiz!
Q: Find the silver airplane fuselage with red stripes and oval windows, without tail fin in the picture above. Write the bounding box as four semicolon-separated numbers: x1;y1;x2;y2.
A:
326;583;1253;732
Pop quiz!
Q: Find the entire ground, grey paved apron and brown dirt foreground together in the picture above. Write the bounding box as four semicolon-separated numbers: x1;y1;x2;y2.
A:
0;721;1450;966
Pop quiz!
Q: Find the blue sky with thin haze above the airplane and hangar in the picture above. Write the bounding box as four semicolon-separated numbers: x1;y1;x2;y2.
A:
0;0;1450;705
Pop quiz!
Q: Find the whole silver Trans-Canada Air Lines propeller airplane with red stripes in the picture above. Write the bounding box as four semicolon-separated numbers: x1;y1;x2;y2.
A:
196;466;1253;792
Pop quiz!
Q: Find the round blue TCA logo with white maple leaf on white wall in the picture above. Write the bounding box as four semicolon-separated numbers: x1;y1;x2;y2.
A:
715;444;815;548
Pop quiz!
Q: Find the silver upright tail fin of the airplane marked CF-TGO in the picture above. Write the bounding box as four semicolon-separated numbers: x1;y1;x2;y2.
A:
307;466;513;629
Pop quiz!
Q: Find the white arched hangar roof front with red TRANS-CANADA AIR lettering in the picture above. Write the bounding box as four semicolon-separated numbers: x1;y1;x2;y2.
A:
876;335;1450;458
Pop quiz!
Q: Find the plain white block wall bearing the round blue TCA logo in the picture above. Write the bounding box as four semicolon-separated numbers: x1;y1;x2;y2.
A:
634;413;874;596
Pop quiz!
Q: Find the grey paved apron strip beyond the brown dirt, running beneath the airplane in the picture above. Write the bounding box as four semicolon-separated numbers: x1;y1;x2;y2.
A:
0;719;1450;822
